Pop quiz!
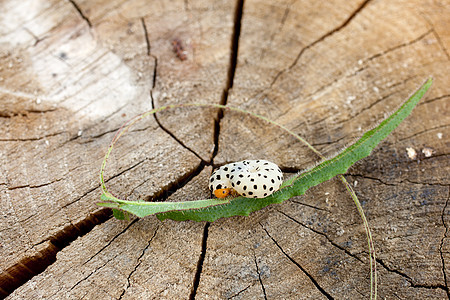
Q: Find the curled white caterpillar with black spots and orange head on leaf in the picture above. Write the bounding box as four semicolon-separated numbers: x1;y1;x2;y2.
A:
209;160;283;198
